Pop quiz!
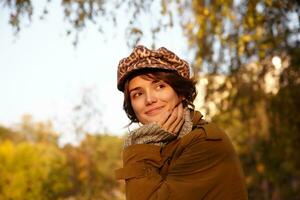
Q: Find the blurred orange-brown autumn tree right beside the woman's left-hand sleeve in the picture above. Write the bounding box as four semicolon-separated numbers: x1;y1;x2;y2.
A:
64;135;124;200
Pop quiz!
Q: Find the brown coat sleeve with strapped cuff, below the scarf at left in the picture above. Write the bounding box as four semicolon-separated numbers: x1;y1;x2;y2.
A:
116;144;168;200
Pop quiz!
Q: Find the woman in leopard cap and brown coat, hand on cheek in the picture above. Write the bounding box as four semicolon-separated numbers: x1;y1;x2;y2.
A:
116;46;247;200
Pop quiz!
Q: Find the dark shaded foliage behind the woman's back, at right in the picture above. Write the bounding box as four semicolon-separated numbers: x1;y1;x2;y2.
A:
213;48;300;200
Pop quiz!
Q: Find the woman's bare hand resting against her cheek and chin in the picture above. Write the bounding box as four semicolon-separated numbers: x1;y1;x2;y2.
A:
157;102;184;134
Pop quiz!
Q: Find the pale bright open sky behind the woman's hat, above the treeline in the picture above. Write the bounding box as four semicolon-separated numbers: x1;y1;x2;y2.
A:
0;0;188;143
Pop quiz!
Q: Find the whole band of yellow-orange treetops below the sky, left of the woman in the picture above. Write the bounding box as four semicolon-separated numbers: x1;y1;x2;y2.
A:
0;121;124;200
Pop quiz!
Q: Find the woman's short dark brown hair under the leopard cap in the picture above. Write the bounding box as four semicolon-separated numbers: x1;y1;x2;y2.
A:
123;69;197;123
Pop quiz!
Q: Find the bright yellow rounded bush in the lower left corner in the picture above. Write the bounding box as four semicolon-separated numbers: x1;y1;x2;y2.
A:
0;140;72;200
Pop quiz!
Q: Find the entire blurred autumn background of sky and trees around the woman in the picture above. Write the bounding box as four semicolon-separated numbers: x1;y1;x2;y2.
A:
0;0;300;200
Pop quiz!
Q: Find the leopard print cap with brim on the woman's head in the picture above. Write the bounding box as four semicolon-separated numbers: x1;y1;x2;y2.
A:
118;45;190;92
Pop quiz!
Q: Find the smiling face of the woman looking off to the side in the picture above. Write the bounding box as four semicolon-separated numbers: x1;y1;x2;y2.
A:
128;75;181;124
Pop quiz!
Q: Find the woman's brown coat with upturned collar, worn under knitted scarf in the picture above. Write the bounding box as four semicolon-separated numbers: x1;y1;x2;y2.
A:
116;112;248;200
